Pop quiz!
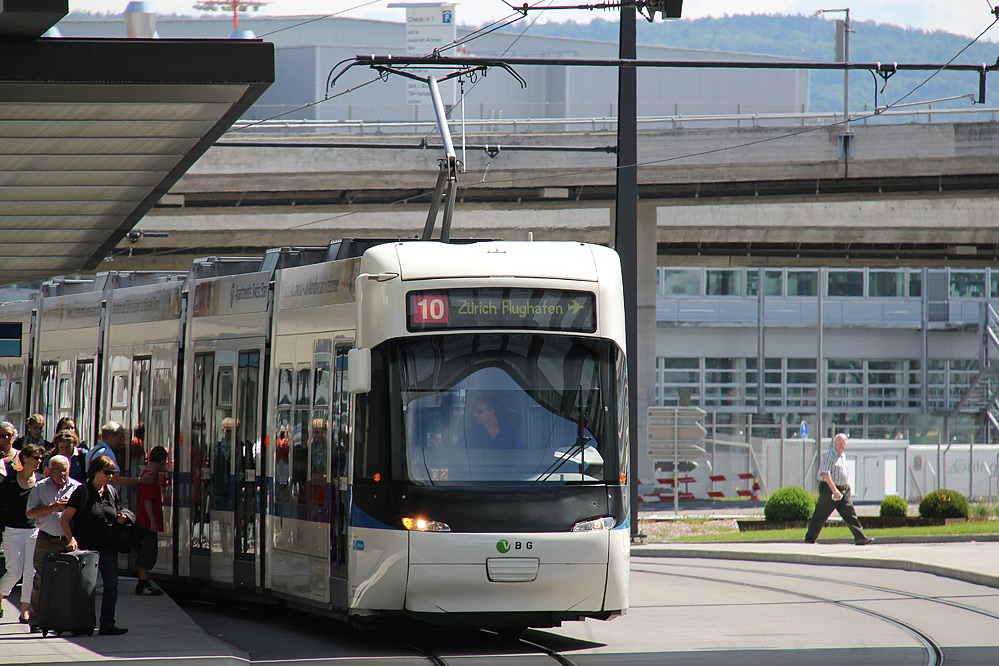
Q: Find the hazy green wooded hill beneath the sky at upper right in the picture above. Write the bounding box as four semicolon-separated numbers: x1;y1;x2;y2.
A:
500;14;999;111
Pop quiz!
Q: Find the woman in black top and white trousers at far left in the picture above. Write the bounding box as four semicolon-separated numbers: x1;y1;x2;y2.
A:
0;444;45;624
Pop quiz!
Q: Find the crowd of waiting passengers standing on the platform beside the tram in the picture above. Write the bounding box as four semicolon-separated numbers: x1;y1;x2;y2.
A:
0;414;169;636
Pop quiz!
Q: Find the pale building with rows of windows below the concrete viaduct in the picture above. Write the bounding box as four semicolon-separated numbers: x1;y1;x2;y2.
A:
654;267;999;441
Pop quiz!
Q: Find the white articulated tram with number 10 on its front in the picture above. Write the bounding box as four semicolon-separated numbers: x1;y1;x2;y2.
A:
0;240;630;627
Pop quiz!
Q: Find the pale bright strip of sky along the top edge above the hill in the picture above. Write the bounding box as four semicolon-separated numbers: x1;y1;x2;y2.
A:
70;0;999;42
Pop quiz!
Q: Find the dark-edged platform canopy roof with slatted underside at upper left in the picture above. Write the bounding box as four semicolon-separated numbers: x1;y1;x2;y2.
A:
0;0;274;286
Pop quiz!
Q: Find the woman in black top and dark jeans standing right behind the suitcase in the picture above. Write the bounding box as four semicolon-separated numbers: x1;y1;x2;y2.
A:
61;456;128;636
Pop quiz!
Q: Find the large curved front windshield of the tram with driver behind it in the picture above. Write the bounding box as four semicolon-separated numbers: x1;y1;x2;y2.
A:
396;333;624;486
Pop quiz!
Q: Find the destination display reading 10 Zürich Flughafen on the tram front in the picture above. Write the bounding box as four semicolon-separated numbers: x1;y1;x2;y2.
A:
406;287;597;333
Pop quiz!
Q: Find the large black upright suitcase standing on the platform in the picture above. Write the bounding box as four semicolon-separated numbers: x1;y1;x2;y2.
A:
32;550;98;636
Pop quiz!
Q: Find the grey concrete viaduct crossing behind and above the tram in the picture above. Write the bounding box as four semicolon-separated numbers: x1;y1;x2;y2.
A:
113;116;999;270
